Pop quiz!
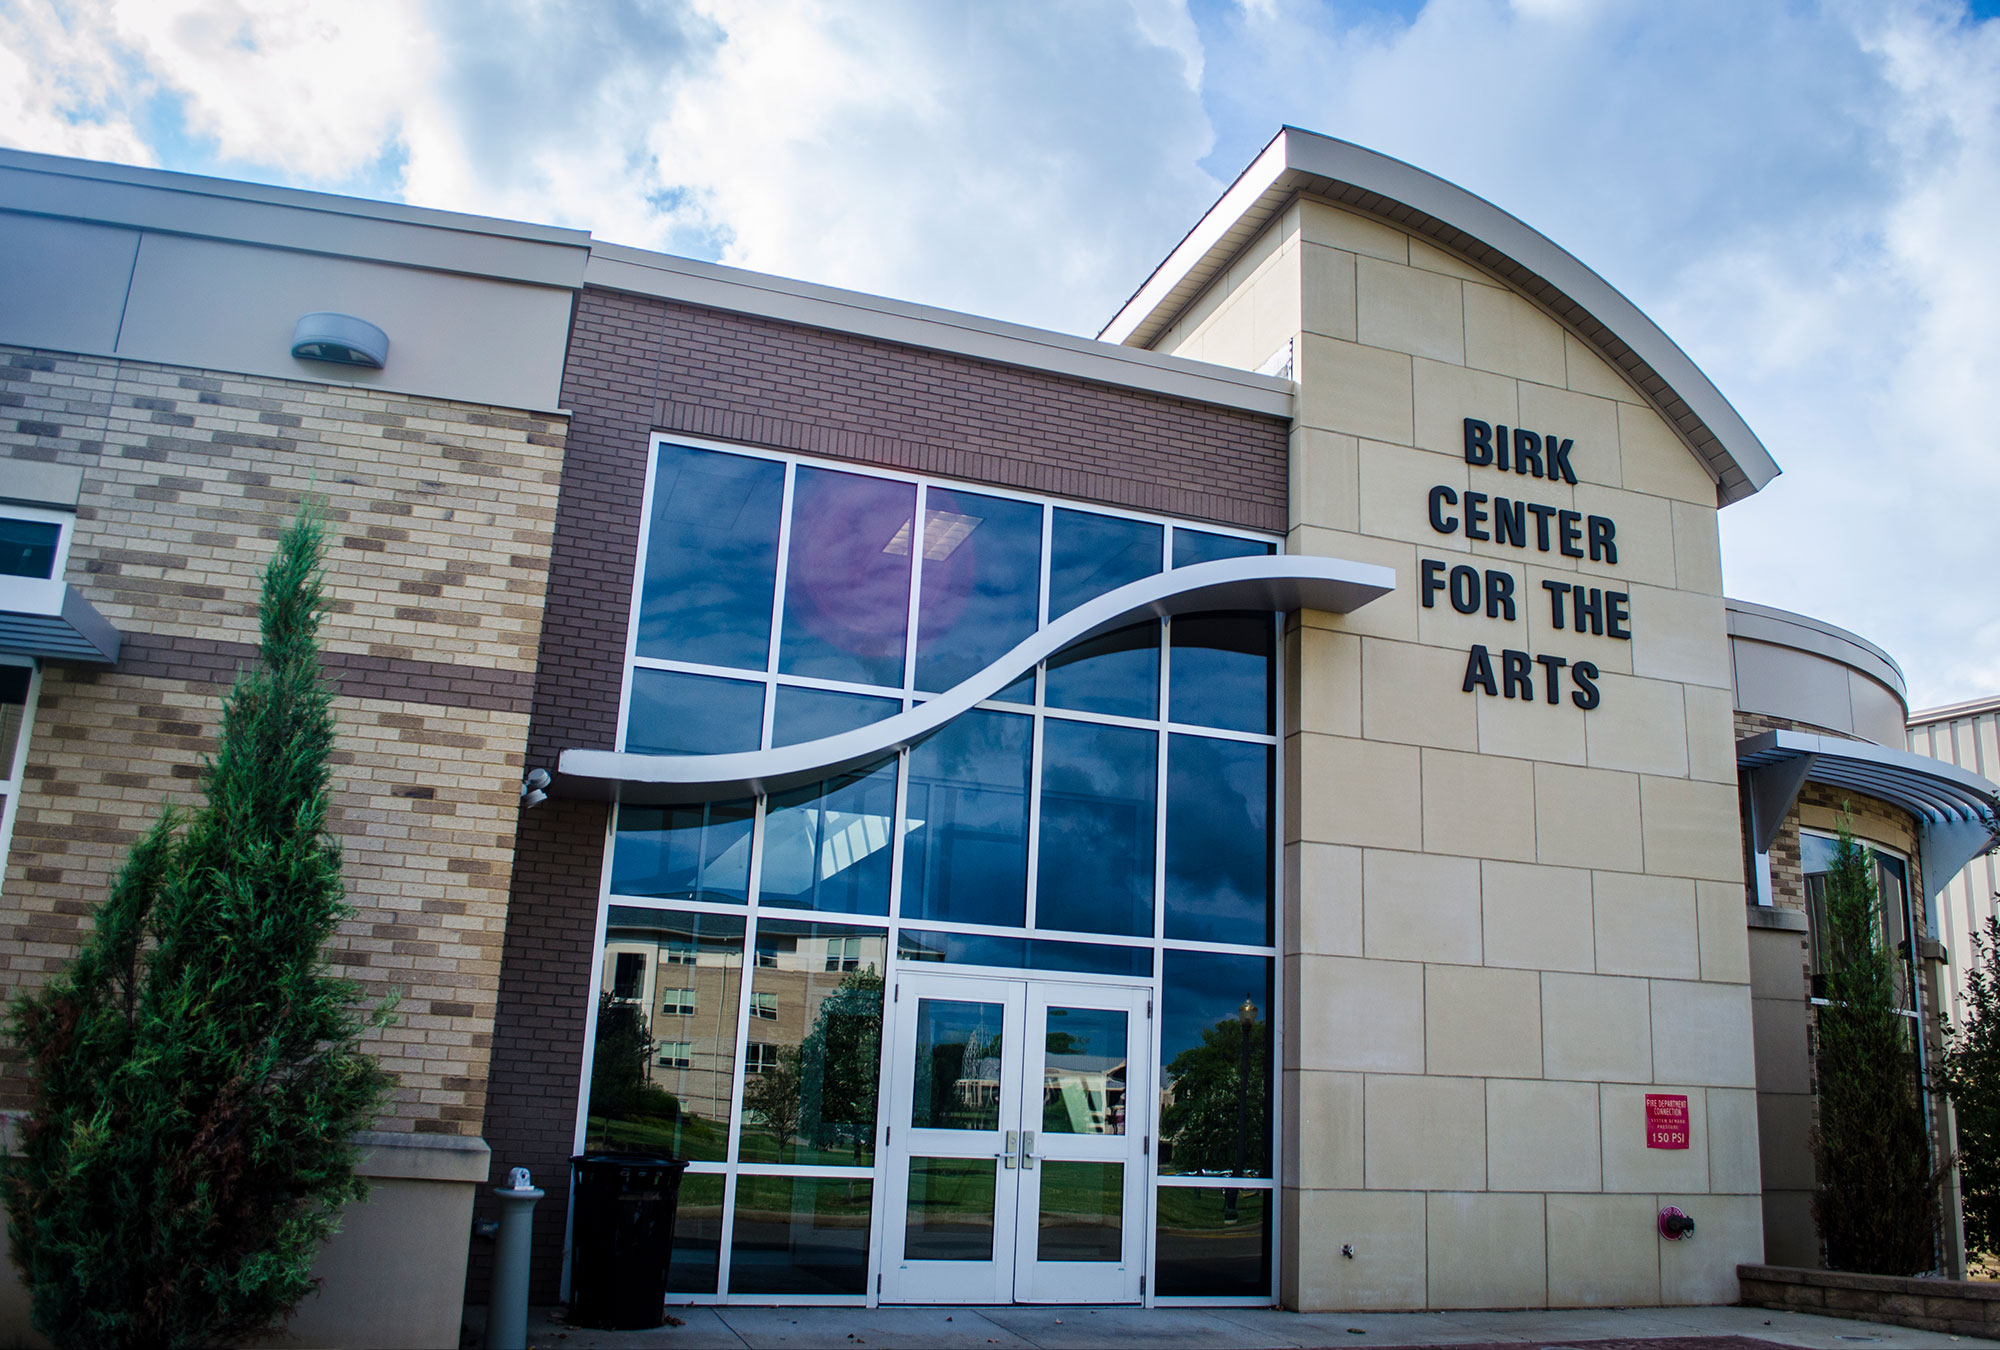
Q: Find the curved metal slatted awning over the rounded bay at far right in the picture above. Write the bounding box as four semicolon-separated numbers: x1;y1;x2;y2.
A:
1736;732;2000;898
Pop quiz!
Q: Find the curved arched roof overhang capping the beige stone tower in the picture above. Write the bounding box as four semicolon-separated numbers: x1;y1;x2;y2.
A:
1098;126;1780;506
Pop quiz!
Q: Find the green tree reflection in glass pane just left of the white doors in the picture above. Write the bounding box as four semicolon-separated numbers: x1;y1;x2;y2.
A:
744;966;882;1162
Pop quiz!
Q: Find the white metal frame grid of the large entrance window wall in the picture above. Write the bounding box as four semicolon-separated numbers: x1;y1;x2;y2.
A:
564;432;1286;1308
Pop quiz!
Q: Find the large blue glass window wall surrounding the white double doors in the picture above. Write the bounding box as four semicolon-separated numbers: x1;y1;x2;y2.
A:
578;440;1278;1302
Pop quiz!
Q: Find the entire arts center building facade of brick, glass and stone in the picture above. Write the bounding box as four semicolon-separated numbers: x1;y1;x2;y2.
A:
0;130;1994;1340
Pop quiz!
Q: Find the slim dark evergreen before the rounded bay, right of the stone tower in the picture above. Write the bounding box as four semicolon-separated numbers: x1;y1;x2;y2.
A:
1812;822;1938;1276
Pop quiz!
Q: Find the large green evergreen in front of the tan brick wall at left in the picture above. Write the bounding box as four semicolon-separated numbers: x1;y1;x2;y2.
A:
4;510;388;1346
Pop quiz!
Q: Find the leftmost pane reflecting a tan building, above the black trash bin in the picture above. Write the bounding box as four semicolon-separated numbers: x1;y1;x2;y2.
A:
584;904;744;1162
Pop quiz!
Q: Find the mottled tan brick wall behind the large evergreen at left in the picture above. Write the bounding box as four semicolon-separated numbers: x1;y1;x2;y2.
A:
0;348;566;1134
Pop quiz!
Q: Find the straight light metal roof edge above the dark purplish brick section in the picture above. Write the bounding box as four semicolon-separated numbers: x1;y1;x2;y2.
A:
584;242;1294;418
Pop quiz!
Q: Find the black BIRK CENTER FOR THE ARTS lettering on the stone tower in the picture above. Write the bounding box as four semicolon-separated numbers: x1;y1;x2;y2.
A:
1418;418;1632;712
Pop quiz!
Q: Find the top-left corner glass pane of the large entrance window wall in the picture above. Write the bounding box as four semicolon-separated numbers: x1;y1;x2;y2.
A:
638;446;784;670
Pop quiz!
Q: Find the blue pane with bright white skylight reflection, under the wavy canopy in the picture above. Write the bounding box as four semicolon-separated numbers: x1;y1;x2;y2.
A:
758;760;896;914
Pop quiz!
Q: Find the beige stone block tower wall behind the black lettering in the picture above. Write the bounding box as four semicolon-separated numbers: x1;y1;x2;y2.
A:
1160;198;1762;1308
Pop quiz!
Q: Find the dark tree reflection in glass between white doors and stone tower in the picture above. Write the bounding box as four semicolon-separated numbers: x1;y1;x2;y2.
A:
1160;1016;1270;1176
